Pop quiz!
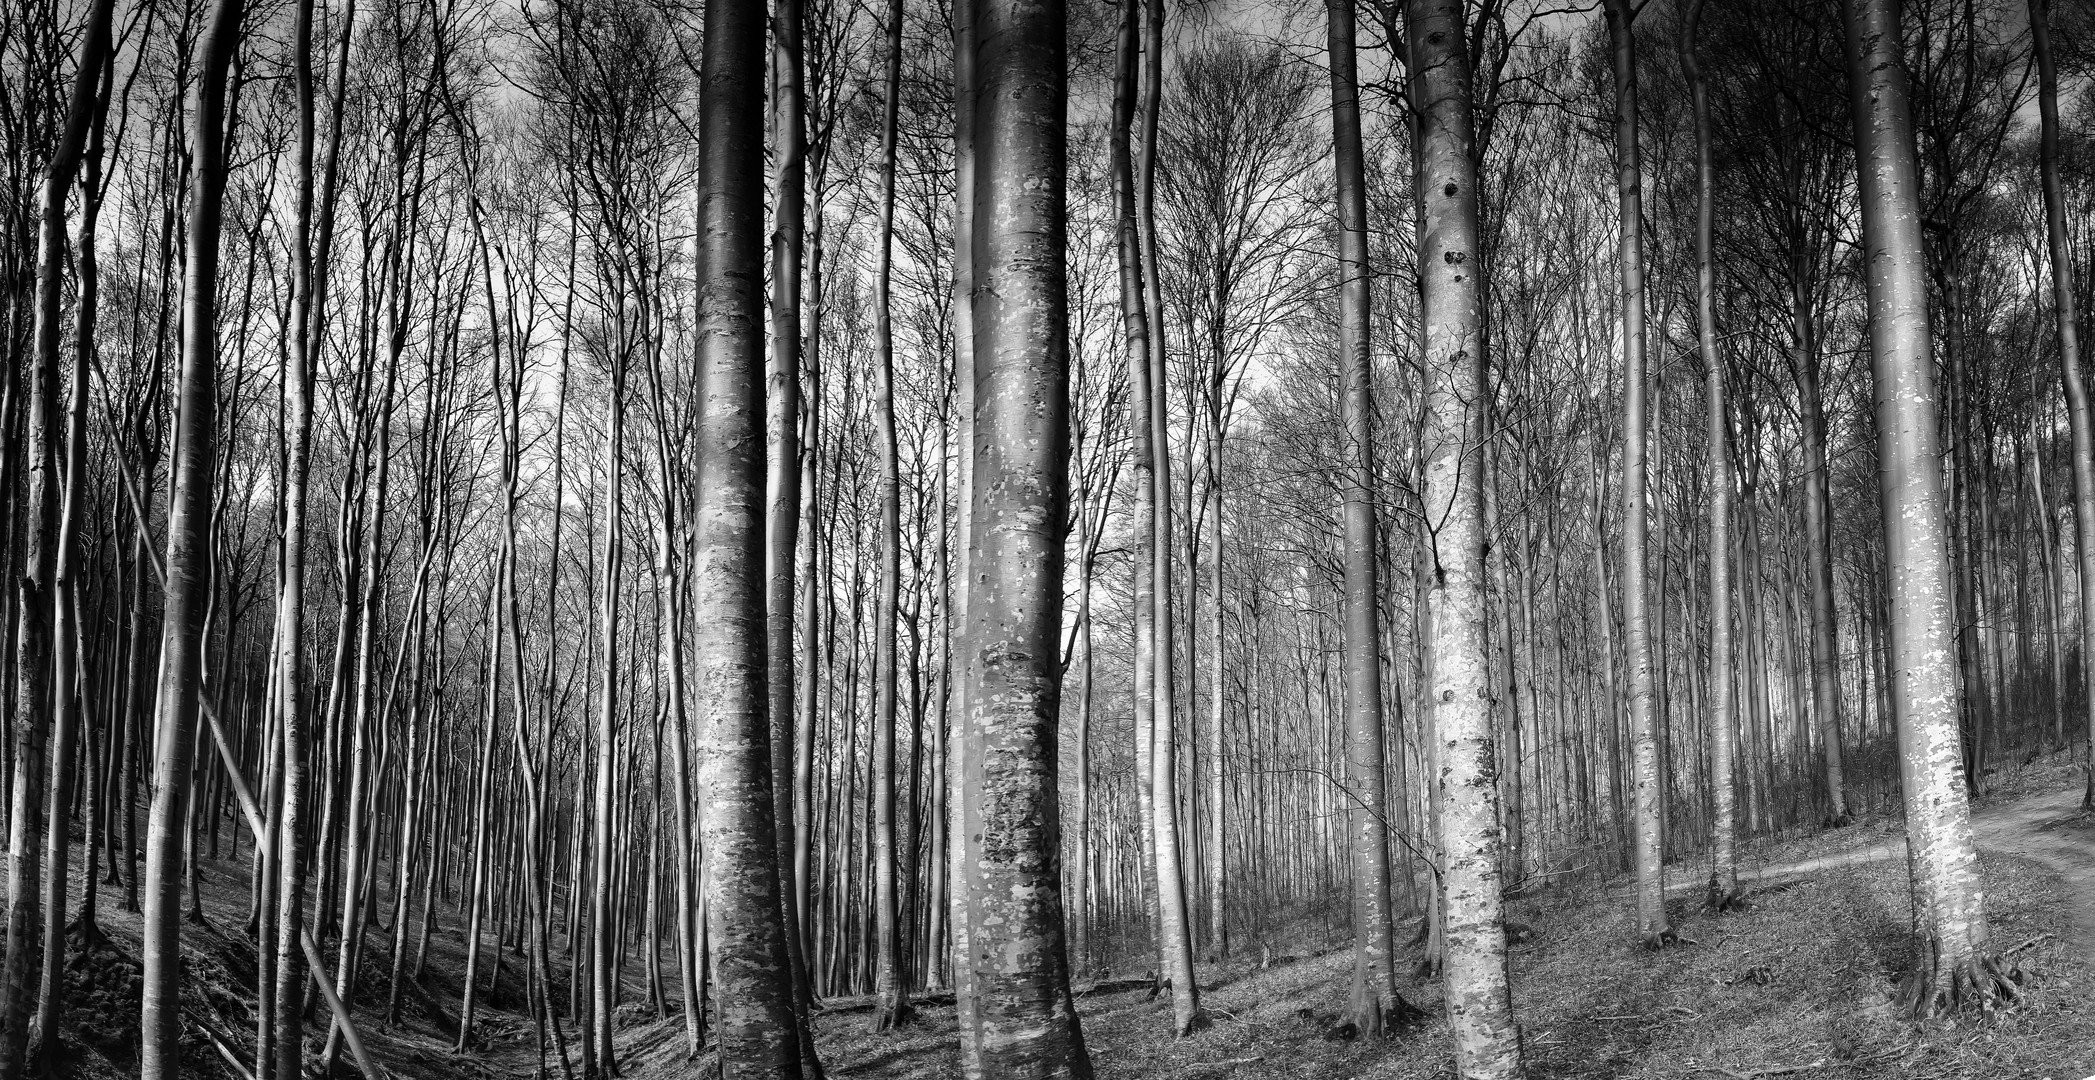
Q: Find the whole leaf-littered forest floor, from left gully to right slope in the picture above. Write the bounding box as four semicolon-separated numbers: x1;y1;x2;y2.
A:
32;760;2095;1080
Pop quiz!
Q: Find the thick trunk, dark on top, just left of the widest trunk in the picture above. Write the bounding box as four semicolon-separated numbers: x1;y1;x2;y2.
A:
691;0;802;1078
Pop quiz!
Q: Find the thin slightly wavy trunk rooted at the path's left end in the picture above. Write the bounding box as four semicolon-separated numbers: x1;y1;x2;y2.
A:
1680;0;1741;910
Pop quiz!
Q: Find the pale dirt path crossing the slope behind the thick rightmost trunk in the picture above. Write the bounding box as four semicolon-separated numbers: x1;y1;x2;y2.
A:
1709;785;2095;957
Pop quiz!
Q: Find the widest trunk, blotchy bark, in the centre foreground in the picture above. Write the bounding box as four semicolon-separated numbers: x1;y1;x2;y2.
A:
953;0;1091;1080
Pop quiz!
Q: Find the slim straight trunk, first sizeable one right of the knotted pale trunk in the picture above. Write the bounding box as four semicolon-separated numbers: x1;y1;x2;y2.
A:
1607;0;1674;946
